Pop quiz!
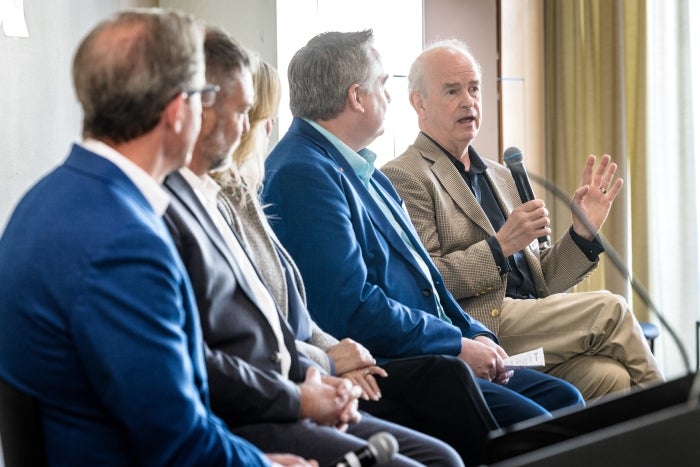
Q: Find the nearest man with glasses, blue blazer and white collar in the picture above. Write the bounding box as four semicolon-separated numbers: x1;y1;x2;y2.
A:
0;9;309;466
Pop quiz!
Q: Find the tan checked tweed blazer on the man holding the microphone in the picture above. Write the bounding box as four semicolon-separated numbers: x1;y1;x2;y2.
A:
381;132;598;335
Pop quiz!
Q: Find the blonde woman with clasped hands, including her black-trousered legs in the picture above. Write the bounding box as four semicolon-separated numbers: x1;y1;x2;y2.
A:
213;55;504;465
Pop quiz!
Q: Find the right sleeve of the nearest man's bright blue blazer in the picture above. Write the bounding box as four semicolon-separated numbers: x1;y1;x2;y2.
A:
72;226;268;466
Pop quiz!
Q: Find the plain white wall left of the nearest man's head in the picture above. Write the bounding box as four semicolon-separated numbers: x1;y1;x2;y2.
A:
0;0;156;231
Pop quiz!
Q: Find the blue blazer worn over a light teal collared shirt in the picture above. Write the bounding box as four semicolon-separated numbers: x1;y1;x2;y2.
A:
263;119;496;359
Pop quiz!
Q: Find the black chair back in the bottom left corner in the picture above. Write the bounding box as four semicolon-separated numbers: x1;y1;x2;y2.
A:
0;380;46;467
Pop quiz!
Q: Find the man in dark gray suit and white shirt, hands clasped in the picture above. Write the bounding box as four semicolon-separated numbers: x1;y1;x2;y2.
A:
164;28;462;466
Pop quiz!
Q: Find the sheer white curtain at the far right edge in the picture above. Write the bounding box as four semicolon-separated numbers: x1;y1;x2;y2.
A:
647;0;700;378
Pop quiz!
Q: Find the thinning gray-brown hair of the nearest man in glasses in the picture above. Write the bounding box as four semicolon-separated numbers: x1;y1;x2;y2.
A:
73;8;204;143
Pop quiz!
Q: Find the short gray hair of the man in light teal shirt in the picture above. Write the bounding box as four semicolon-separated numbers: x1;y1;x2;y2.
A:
288;29;379;120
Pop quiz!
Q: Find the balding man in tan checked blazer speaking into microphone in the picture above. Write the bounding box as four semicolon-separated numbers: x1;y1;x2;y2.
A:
381;40;664;400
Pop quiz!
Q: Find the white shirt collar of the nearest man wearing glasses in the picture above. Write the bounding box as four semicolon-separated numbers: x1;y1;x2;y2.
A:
80;138;170;216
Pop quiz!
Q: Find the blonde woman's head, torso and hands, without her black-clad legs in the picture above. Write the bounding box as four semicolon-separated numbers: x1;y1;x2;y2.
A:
214;60;386;399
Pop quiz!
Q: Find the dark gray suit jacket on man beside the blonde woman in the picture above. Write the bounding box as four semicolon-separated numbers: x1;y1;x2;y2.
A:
164;172;315;427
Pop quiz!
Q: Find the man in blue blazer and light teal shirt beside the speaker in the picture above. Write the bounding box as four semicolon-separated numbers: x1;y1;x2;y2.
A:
263;27;583;434
